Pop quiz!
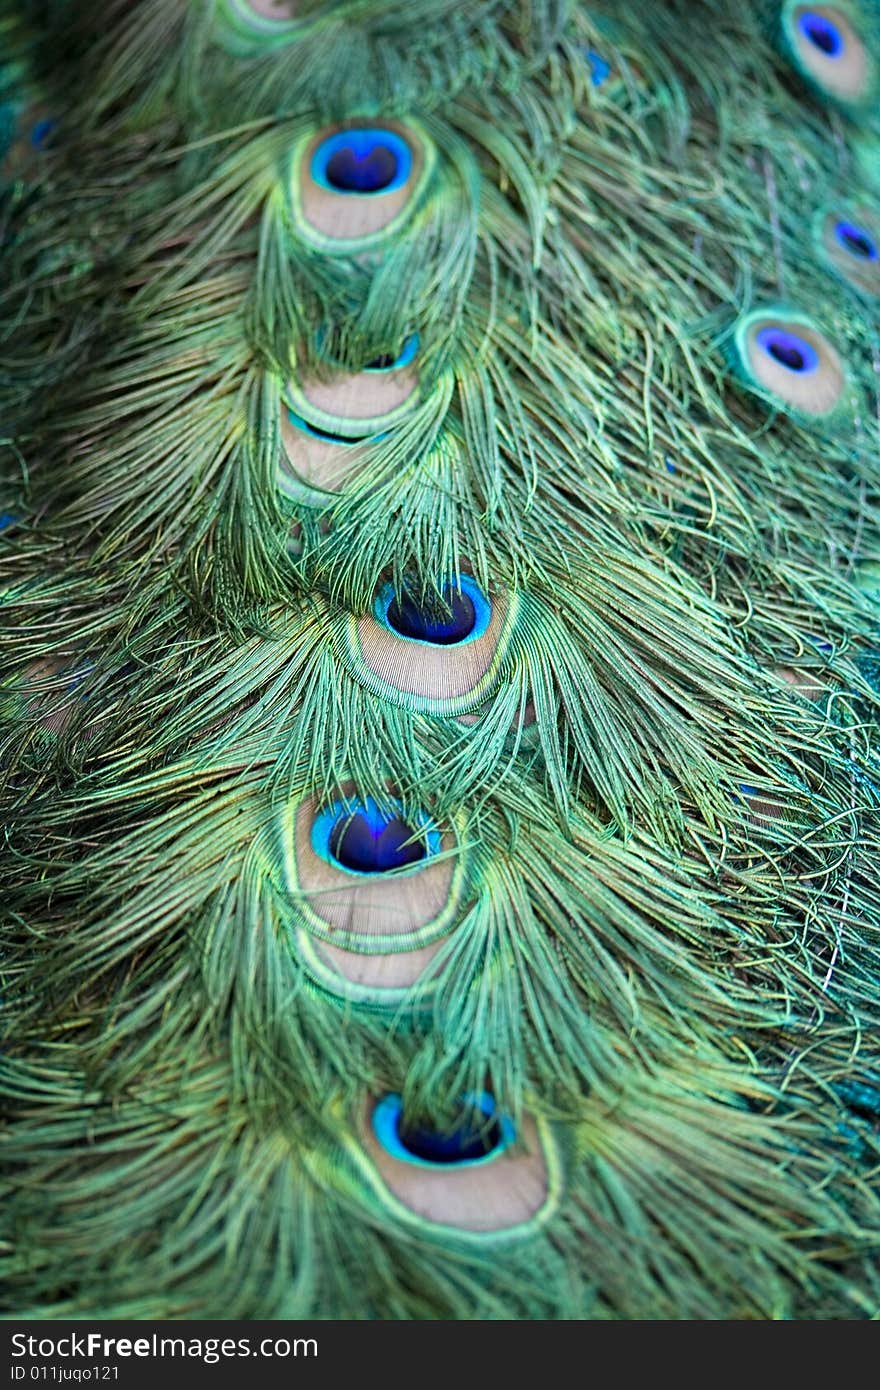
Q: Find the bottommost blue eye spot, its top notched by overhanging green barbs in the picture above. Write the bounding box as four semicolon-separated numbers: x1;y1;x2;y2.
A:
373;1091;516;1169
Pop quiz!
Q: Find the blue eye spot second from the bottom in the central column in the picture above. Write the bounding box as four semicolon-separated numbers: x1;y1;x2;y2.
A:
311;796;441;874
